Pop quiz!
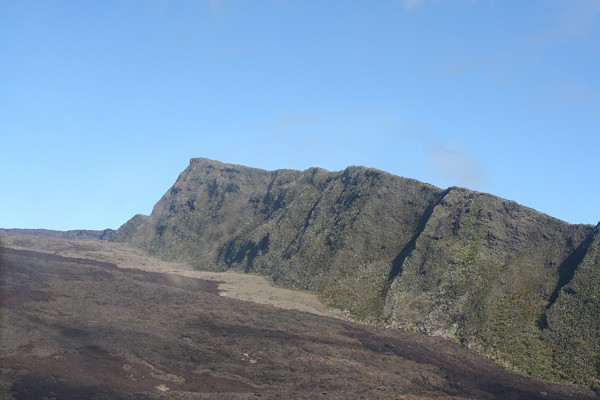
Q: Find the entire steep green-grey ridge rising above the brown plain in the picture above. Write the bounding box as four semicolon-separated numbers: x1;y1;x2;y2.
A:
115;159;600;387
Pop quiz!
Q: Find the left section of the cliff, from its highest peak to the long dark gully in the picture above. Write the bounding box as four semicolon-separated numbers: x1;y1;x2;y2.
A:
115;159;442;319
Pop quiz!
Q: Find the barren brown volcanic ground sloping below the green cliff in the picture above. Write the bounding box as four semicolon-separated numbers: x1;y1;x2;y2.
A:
0;237;595;400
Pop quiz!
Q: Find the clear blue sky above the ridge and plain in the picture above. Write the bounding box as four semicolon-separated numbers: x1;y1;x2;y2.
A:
0;0;600;229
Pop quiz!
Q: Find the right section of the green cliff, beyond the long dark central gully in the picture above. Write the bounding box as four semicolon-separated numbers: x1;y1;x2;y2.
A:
384;189;600;384
